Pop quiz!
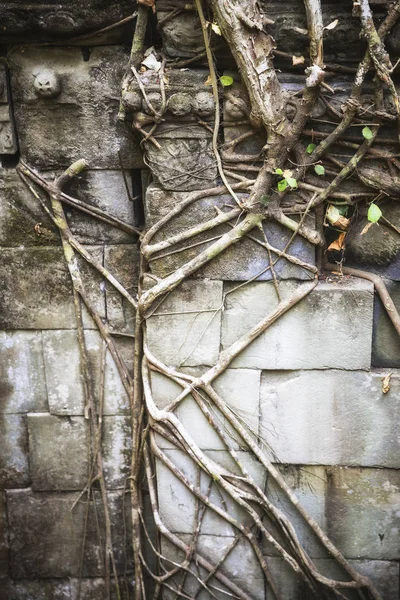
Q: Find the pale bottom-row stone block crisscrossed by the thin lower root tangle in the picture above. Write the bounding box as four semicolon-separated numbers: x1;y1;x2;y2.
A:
162;534;266;600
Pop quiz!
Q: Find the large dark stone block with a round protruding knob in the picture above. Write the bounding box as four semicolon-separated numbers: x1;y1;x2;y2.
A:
10;46;143;169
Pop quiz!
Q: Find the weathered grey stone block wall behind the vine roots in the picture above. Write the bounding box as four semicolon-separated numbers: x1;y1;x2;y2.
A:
0;2;400;600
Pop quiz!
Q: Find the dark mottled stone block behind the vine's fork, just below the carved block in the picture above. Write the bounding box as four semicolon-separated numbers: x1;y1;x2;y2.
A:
146;184;315;281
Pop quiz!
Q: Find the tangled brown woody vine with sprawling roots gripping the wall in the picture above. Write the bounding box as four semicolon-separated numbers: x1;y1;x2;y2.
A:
18;0;400;600
